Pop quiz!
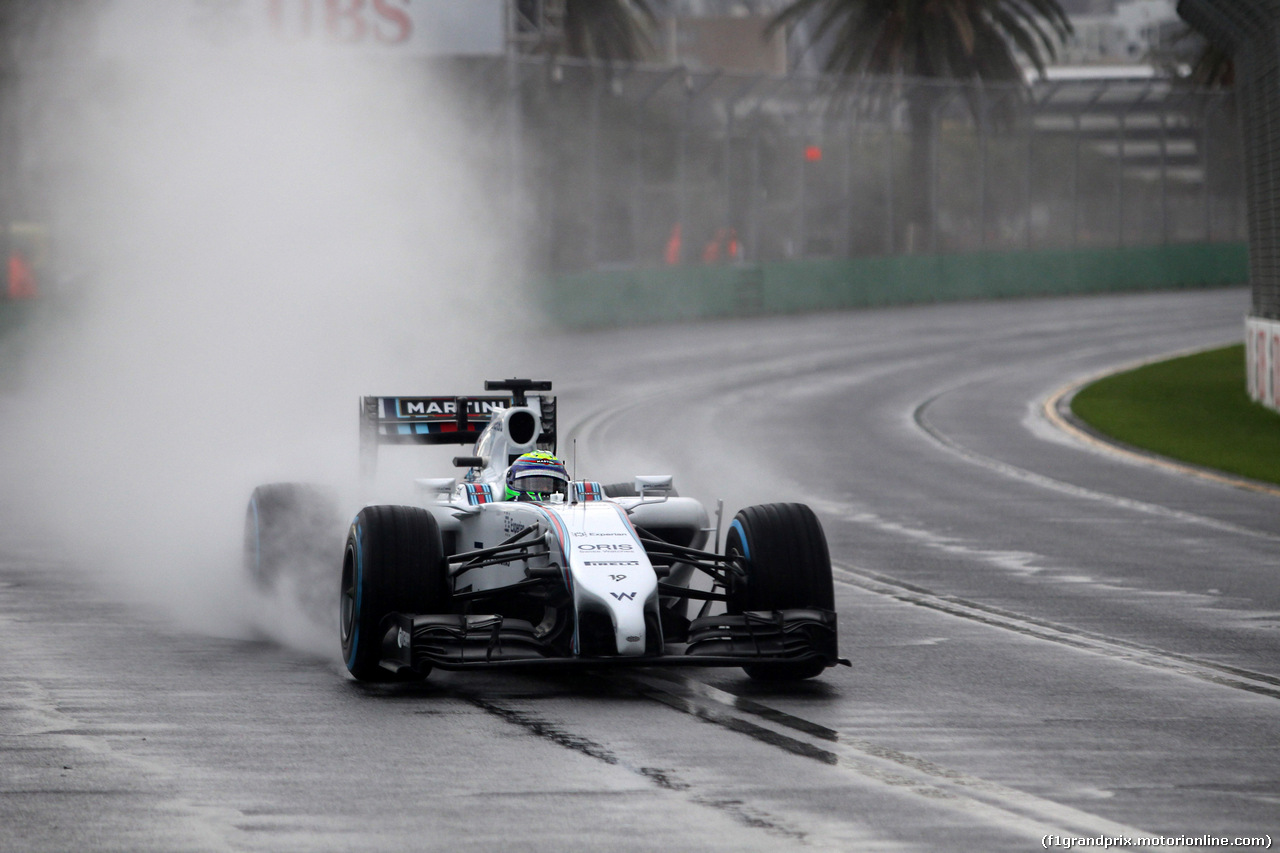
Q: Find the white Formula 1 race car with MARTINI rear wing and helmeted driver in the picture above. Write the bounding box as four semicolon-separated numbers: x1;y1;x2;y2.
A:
246;379;849;681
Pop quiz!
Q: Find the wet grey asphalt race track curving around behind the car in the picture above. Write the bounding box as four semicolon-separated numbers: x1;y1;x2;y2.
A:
0;289;1280;852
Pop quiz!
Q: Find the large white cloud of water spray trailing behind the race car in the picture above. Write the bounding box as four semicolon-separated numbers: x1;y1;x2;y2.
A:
5;4;521;645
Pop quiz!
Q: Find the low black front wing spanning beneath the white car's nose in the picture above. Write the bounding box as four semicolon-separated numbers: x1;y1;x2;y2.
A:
381;608;850;672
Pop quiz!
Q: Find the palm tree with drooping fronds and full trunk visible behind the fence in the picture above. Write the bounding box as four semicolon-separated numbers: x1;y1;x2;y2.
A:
767;0;1073;245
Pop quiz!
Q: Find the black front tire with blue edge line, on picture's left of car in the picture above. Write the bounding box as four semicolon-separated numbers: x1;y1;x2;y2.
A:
339;506;449;681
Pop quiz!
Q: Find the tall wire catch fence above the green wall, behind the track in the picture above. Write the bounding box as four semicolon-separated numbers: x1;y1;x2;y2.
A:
458;59;1247;279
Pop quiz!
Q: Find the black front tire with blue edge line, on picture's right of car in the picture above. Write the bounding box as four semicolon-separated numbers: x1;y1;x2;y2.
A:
724;503;836;681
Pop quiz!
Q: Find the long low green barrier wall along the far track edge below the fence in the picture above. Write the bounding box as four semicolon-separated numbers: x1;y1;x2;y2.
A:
548;243;1249;328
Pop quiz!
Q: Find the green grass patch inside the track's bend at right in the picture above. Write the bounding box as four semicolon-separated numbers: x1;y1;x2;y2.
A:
1071;343;1280;483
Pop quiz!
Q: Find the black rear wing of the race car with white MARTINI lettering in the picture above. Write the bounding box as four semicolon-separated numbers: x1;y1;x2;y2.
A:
360;379;556;475
